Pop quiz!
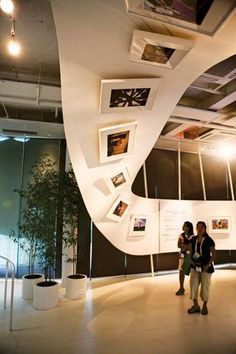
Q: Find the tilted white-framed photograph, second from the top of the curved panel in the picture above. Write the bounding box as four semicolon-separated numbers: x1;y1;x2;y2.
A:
129;30;194;69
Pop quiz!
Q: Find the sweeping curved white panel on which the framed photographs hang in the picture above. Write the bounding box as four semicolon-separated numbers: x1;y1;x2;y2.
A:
52;0;236;255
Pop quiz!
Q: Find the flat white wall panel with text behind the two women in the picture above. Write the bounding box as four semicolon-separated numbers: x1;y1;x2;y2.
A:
160;200;236;253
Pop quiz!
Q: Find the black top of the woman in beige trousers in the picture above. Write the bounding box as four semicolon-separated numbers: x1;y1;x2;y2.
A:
190;235;215;273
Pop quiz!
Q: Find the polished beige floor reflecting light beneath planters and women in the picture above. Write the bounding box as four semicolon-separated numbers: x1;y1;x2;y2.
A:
0;269;236;354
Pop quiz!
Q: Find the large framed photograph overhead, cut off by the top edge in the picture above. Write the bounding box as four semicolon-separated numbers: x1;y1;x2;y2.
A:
126;0;235;36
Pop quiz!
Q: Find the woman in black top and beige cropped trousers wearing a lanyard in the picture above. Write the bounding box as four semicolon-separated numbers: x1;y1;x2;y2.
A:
188;221;215;315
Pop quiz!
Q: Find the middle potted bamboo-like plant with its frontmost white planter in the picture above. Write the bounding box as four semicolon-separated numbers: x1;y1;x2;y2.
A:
31;155;59;310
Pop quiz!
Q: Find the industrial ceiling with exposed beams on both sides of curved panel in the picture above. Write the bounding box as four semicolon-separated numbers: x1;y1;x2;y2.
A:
0;0;236;147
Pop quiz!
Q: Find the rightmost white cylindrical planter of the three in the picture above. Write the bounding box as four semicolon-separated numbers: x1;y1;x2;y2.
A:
65;274;87;300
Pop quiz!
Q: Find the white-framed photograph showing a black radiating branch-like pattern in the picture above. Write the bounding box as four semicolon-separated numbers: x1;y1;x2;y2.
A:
99;78;161;113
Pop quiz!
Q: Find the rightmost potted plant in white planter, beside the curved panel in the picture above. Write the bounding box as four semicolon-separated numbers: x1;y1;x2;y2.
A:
61;168;87;300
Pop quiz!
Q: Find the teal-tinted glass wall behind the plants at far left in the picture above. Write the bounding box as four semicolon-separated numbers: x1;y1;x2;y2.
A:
0;138;60;276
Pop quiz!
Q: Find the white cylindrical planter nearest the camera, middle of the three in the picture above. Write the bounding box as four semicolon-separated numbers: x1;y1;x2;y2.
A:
34;281;58;310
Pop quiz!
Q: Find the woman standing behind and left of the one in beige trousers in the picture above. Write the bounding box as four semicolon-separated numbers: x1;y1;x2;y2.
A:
175;221;193;295
